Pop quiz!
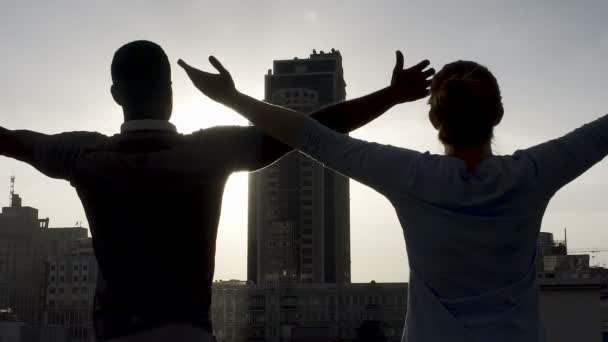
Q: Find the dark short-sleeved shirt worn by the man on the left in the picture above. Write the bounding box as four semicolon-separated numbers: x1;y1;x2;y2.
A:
32;120;289;339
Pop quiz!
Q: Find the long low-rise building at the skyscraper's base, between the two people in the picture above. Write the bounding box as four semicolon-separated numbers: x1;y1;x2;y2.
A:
212;281;407;342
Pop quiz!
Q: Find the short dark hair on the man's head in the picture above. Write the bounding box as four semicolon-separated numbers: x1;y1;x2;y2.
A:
111;40;171;97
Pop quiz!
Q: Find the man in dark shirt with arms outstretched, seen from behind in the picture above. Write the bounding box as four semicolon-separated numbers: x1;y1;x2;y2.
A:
0;41;428;341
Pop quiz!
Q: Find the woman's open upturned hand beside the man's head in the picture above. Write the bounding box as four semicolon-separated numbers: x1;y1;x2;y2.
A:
177;56;238;104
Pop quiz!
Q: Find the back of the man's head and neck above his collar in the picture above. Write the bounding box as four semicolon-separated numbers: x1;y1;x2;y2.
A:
111;40;172;119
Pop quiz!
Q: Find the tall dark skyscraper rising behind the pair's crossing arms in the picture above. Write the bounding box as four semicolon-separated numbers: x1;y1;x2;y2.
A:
247;49;351;284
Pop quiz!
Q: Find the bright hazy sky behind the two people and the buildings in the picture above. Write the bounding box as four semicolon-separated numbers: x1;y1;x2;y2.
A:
0;0;608;282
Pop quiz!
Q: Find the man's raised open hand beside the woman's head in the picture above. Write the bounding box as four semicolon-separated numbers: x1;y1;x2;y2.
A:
389;51;435;103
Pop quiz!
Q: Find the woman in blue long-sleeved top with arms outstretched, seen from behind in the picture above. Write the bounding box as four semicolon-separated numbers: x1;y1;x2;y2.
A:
182;53;608;342
